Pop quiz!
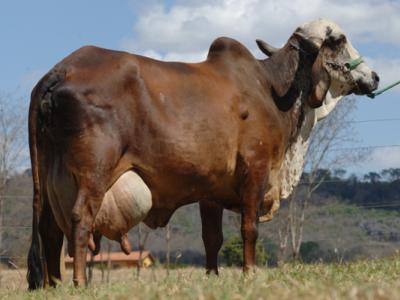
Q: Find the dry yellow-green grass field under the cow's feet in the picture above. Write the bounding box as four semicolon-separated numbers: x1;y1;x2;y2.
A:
0;256;400;300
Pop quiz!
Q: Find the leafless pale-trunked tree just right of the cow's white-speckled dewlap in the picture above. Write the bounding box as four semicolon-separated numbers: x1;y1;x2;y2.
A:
280;99;367;260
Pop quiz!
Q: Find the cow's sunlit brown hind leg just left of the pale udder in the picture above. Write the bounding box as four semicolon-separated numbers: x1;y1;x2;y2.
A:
65;126;122;286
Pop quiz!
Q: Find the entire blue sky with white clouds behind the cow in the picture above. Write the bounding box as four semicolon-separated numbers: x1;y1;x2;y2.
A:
0;0;400;170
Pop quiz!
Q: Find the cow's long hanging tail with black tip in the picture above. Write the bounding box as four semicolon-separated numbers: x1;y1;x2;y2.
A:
26;72;60;290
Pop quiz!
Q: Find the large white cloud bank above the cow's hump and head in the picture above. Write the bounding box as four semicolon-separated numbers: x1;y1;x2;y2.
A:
121;0;400;60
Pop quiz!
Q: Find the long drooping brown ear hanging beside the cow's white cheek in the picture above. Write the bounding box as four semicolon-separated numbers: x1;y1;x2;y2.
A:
308;50;331;108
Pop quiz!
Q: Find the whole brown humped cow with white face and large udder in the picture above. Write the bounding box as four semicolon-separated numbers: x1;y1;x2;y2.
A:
28;20;378;289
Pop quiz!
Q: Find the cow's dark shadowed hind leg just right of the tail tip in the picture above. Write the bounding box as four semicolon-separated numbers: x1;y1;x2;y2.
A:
39;201;64;287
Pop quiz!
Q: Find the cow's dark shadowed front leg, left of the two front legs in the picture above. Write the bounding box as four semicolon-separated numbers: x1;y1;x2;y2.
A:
200;201;223;275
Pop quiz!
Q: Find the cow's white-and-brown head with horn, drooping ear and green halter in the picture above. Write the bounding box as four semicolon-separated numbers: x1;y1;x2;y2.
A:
257;19;379;108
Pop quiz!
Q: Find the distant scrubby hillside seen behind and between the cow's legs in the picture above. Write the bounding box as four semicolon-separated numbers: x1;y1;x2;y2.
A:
1;169;400;265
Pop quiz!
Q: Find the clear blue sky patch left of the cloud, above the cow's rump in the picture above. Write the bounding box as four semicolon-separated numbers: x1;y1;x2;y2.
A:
0;0;134;90
